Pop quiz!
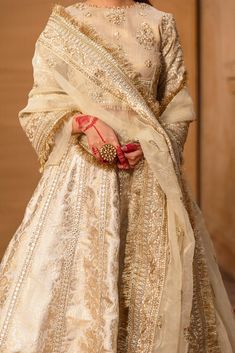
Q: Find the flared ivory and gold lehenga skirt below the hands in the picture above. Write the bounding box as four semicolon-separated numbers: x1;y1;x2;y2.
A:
0;144;232;353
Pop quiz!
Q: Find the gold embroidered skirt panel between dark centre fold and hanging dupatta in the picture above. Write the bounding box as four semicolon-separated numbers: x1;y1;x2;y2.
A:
118;161;169;353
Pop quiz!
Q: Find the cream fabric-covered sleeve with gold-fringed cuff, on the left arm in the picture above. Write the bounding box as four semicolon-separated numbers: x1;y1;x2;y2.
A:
18;44;79;172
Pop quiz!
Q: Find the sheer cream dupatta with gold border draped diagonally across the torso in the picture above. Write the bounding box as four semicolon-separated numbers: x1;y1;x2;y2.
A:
19;5;235;353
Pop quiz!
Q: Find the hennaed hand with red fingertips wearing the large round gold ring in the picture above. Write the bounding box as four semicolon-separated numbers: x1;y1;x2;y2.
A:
72;114;130;169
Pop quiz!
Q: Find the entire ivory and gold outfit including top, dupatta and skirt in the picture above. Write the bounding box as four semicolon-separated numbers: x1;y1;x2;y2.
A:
0;3;235;353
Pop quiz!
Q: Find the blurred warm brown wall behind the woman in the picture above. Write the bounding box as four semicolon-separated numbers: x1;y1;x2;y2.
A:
0;0;235;300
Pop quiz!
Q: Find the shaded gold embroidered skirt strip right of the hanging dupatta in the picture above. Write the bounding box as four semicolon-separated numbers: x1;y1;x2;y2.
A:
179;175;221;353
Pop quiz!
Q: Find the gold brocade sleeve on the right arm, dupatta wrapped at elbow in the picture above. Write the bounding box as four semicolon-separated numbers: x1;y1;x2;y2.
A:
157;13;196;164
